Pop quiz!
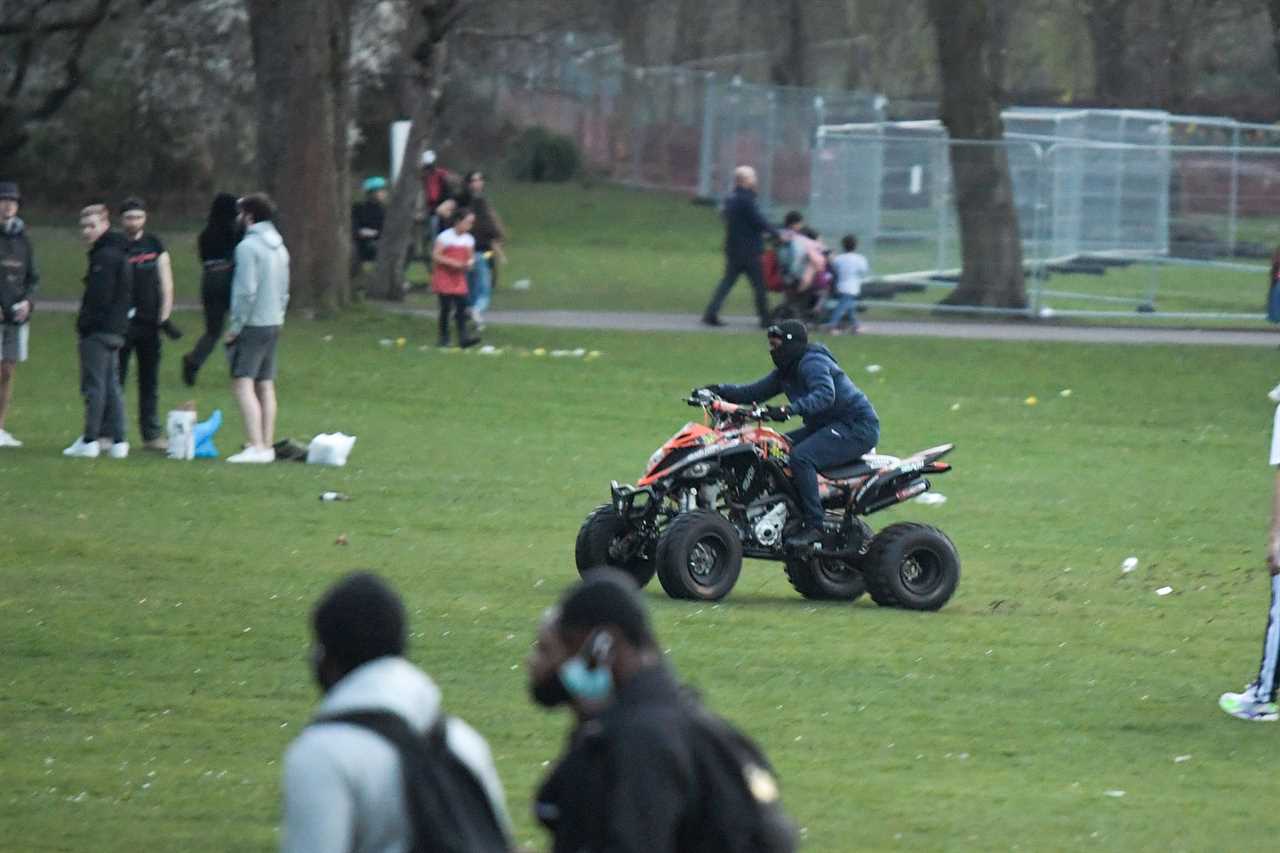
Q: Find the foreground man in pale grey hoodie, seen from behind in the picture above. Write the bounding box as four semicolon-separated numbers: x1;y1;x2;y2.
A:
280;573;511;853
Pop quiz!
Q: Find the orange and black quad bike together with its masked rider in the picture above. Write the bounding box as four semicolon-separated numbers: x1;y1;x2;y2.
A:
573;317;960;610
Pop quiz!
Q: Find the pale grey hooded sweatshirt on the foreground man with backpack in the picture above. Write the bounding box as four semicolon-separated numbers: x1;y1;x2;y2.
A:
280;657;511;853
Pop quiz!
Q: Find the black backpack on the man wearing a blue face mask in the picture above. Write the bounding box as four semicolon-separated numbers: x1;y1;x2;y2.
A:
686;697;797;853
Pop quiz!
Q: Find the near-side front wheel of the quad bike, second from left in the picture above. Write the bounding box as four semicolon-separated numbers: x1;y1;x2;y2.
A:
655;510;742;601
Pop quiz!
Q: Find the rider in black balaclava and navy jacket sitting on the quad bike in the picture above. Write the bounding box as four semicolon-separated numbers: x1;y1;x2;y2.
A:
708;320;879;547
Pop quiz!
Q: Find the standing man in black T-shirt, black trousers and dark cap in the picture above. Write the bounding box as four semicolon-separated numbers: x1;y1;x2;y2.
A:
120;197;173;451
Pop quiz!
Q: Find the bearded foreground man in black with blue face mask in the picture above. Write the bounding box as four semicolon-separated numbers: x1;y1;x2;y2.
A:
527;569;788;853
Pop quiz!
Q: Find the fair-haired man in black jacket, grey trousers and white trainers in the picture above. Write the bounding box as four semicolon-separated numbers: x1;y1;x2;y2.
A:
63;205;133;459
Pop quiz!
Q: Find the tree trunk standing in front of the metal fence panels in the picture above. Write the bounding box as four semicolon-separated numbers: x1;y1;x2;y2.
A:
929;0;1027;309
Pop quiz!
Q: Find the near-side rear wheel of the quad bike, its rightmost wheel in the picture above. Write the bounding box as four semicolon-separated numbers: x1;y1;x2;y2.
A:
863;523;960;610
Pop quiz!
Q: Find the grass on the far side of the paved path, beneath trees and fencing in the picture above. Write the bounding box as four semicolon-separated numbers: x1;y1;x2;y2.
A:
22;183;1266;327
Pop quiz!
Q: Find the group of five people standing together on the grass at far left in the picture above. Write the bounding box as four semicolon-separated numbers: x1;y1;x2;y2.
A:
0;182;289;462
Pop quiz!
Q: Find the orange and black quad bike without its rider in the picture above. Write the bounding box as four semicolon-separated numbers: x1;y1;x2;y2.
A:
575;389;960;610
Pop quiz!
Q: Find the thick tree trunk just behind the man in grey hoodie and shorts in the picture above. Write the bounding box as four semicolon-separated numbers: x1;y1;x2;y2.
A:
248;0;351;315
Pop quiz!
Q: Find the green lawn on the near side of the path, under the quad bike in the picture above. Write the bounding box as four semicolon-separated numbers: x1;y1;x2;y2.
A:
0;303;1280;852
